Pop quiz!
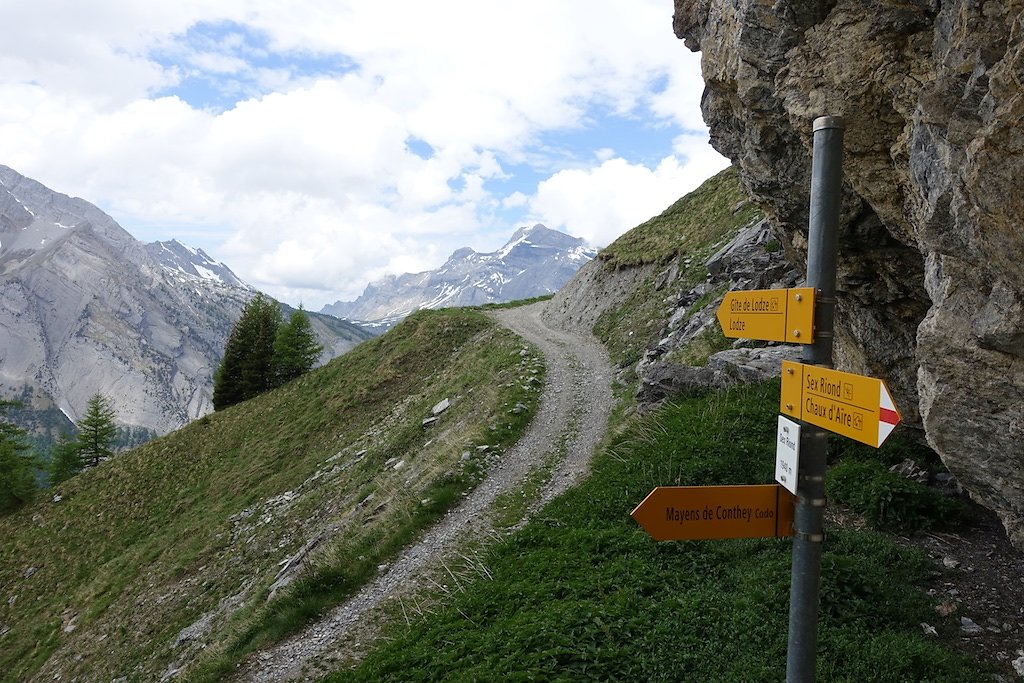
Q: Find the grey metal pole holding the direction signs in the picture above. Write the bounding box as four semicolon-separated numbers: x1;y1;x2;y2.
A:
785;117;844;683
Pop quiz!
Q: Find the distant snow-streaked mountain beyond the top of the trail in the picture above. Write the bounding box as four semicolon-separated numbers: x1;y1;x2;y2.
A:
321;224;597;329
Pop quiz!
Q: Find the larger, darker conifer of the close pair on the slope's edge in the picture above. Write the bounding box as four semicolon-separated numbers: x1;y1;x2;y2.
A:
213;294;282;411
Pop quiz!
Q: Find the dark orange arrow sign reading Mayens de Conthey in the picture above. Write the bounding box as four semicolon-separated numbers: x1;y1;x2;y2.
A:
630;484;793;541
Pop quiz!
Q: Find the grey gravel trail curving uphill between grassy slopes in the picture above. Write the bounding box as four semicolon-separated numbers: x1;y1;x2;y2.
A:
236;302;612;683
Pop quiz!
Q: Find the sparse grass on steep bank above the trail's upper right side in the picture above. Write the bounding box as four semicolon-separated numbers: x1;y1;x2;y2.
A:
594;168;760;367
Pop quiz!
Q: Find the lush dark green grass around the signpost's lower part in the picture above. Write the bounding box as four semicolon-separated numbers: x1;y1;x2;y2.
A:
327;382;985;683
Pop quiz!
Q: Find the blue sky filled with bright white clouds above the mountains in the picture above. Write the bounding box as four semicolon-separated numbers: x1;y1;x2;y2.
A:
0;0;726;309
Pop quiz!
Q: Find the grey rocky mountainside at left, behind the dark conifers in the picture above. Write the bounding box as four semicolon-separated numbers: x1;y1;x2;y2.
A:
0;166;369;433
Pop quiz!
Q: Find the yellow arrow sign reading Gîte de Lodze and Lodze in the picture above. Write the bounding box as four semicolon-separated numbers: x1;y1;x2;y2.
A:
718;287;814;344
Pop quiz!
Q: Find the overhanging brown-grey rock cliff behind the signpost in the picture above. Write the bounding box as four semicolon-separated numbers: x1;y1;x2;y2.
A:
674;0;1024;547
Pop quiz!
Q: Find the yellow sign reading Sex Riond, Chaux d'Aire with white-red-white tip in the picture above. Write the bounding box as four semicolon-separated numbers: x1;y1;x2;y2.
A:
779;360;900;447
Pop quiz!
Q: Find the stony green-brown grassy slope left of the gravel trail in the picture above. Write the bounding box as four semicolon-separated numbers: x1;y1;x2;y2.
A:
0;310;537;680
